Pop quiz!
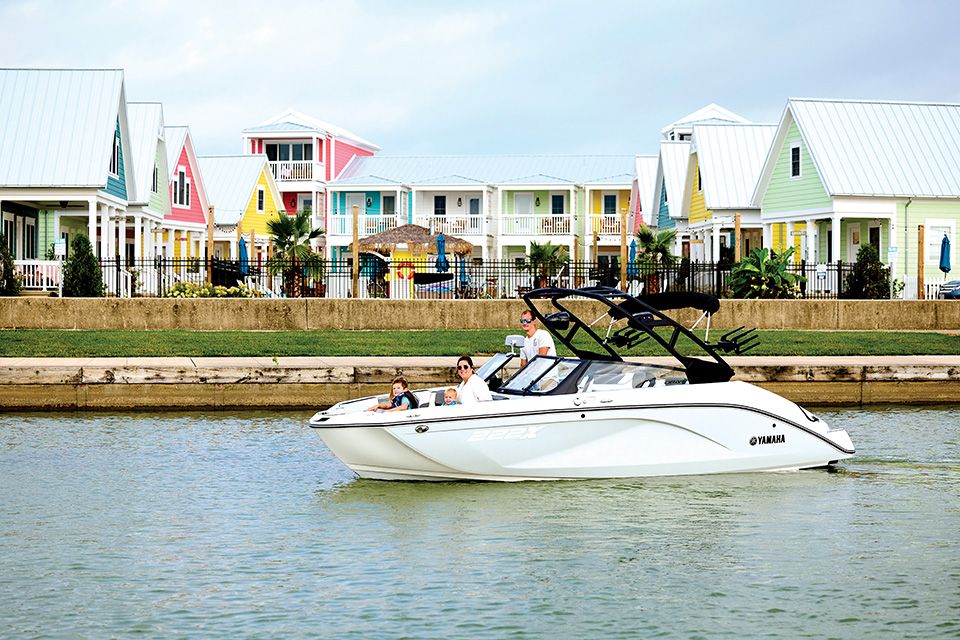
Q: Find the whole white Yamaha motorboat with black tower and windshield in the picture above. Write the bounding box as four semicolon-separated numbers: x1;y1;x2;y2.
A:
309;287;855;481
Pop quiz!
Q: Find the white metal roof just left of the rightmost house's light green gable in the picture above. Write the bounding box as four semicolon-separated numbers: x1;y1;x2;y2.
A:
688;124;777;210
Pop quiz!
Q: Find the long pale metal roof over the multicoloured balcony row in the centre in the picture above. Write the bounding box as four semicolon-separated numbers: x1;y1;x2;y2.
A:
331;155;635;188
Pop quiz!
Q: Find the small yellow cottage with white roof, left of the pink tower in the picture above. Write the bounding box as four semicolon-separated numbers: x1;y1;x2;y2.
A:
200;154;287;264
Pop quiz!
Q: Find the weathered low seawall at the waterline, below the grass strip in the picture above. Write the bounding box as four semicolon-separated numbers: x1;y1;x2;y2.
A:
0;356;960;411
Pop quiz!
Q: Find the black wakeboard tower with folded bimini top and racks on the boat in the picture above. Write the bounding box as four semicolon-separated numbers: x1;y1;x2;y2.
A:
523;287;757;384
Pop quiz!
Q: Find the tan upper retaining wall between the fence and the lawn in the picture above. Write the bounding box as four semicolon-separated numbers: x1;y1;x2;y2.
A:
0;298;960;331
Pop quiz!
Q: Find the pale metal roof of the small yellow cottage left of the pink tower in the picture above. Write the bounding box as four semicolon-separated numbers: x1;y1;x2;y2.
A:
197;153;268;226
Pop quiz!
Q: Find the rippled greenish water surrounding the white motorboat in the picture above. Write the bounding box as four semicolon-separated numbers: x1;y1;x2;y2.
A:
0;407;960;639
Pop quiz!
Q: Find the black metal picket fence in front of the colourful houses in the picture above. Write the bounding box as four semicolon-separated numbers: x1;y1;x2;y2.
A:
101;255;853;299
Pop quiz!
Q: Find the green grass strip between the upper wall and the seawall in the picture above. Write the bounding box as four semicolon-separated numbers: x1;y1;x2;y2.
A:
0;329;960;358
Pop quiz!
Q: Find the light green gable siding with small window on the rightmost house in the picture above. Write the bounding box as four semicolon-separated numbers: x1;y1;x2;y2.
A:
762;122;833;213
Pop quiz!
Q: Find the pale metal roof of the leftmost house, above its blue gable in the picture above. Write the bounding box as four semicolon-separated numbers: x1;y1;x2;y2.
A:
0;69;125;187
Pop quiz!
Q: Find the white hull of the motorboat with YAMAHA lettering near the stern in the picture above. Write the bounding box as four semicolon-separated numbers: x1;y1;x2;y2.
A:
310;382;854;481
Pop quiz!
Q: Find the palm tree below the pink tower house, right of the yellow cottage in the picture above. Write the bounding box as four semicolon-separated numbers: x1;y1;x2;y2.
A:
267;210;326;298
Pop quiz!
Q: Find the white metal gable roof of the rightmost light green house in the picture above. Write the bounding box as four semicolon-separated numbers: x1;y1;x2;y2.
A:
754;98;960;202
